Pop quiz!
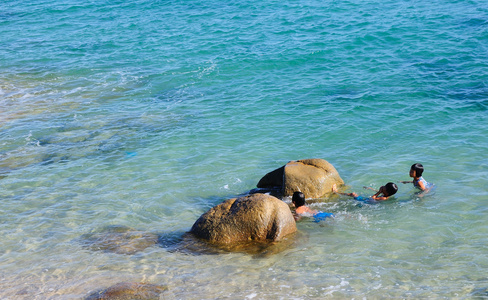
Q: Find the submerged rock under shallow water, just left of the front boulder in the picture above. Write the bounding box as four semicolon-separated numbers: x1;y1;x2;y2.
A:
82;226;158;254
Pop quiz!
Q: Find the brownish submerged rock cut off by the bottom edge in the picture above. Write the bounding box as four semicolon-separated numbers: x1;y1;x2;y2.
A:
85;282;168;300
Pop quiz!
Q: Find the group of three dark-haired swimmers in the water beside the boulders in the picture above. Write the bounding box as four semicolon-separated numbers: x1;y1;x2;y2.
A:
291;163;433;220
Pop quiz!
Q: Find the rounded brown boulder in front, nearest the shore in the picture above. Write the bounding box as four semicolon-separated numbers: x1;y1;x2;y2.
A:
190;194;297;245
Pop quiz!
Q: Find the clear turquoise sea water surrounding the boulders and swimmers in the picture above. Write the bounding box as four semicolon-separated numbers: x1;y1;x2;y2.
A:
0;0;488;299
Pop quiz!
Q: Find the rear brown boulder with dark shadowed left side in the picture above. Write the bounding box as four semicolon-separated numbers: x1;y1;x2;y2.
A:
257;158;344;198
